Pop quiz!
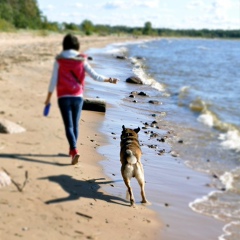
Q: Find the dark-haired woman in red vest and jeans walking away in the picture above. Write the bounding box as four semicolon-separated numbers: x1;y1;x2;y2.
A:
45;34;118;165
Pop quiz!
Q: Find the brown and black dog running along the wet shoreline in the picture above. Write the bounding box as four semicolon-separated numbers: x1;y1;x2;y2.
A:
120;125;148;206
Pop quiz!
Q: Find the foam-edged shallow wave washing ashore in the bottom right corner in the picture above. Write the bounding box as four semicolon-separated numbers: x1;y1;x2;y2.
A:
189;167;240;240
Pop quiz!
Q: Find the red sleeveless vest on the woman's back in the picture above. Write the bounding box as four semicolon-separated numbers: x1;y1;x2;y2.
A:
57;56;85;97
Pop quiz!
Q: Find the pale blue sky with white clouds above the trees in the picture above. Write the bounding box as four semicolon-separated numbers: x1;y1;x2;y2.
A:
37;0;240;29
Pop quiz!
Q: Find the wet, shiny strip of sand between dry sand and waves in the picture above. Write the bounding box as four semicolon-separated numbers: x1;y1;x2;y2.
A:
81;36;225;240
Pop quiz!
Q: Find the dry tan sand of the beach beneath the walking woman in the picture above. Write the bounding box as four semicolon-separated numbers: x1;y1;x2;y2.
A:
0;33;161;240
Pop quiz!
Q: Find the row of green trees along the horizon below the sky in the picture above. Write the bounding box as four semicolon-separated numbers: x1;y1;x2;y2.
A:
0;0;240;38
